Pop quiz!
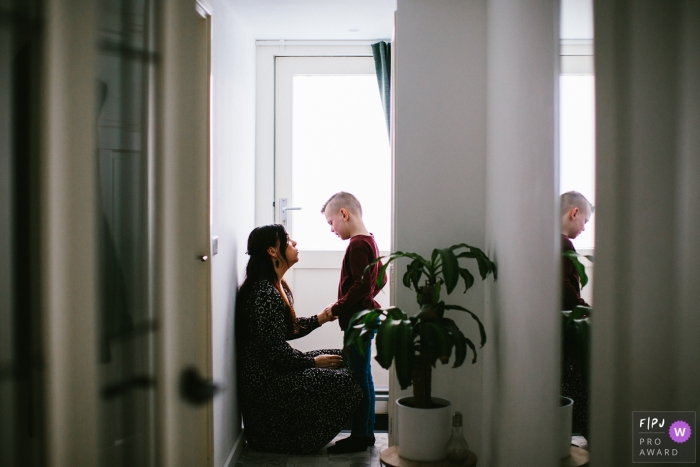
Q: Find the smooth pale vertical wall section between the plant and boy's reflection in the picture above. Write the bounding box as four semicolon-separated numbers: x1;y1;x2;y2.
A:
483;0;561;466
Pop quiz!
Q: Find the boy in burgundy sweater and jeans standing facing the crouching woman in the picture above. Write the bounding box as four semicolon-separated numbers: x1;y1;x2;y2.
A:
321;191;386;454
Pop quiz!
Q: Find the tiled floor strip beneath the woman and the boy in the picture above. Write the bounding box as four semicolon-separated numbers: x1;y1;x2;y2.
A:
236;433;389;467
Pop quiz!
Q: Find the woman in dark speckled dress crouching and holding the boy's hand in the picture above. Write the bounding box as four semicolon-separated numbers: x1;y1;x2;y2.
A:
236;225;361;454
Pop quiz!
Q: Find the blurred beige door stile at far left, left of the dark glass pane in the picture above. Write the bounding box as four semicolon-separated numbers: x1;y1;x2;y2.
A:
39;0;99;466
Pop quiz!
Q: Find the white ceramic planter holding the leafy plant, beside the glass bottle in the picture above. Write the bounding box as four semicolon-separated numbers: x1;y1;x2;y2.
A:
396;397;452;462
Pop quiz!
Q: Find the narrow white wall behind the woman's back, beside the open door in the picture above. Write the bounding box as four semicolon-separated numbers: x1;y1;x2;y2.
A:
212;0;255;467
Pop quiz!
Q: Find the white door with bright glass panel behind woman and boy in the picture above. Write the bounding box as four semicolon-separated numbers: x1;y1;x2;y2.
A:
275;55;391;390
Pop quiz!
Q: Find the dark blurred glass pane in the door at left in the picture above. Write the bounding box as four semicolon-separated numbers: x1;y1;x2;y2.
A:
95;0;156;467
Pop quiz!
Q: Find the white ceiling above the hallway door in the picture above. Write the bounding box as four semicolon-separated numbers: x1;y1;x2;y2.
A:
229;0;396;40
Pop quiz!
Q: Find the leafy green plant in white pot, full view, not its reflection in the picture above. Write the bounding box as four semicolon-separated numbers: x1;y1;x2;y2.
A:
345;243;497;461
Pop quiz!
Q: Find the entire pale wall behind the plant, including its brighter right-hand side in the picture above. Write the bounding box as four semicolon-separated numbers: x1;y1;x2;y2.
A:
394;0;559;466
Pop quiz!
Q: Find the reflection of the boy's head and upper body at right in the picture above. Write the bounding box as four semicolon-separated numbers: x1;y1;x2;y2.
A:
560;191;594;310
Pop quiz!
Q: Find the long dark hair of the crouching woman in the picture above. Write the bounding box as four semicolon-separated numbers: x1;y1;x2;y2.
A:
236;224;297;338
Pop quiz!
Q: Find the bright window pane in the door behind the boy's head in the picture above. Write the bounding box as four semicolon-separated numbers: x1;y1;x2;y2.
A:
292;75;391;250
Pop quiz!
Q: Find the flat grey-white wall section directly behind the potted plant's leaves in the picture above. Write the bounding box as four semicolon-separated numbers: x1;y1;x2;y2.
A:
394;0;486;455
